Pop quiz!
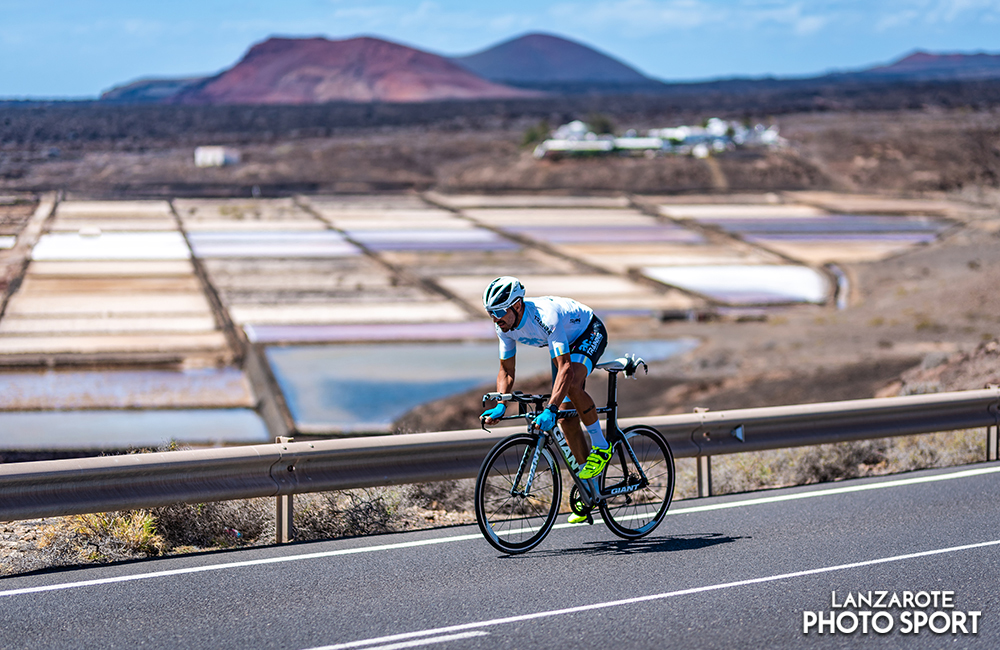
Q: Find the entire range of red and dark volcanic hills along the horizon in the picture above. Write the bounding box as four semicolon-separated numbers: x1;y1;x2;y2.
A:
101;34;1000;105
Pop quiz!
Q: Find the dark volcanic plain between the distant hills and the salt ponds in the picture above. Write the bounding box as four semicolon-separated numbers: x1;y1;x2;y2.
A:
0;88;1000;197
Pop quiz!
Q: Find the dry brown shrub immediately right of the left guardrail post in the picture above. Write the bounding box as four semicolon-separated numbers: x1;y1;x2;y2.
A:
293;487;405;540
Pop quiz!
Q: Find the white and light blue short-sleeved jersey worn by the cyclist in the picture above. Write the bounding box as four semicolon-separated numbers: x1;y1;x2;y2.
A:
496;296;594;359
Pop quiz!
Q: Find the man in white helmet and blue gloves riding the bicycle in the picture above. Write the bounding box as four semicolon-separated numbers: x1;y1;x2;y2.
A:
480;276;611;486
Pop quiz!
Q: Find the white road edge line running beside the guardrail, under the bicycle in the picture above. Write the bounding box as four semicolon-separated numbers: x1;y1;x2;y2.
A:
0;466;1000;597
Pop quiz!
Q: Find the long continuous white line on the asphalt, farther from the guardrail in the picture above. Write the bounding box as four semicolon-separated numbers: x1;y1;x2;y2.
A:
300;539;1000;650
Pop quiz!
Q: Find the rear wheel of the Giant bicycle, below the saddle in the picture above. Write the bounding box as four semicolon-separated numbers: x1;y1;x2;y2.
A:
600;425;674;539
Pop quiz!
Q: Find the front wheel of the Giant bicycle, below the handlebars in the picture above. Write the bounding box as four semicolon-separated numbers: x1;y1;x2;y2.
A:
475;433;562;553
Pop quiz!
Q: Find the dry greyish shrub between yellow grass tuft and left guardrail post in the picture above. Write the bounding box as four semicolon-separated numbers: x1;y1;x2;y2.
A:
153;498;274;547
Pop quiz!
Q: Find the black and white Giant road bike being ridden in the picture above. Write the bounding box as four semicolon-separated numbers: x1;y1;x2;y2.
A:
475;356;674;554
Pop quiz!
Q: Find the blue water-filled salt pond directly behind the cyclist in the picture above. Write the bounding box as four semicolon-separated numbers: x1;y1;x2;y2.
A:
267;338;697;434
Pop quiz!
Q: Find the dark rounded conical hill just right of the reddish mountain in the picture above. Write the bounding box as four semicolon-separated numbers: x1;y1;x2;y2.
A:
451;34;663;92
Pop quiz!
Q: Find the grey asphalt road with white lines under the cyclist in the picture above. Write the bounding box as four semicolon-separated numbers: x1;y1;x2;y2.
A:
0;463;1000;650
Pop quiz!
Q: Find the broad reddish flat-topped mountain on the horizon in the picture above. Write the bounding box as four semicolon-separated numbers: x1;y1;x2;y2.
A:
170;37;538;104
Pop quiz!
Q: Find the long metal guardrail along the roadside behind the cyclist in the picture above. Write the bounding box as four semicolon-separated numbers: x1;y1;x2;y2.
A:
0;386;1000;541
